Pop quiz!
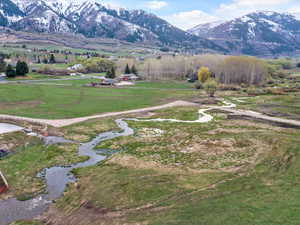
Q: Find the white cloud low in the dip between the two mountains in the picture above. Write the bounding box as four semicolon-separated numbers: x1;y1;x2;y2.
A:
164;10;218;30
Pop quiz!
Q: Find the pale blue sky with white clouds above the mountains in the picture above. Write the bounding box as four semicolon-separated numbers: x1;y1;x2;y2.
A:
99;0;300;29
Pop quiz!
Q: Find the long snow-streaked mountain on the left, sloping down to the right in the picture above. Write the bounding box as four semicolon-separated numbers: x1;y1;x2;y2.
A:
0;0;226;51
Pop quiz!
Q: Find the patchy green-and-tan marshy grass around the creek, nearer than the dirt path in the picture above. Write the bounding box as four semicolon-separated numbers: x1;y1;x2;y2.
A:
0;95;300;225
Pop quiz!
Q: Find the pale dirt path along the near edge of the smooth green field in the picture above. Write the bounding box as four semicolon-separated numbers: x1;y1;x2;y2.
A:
0;101;198;127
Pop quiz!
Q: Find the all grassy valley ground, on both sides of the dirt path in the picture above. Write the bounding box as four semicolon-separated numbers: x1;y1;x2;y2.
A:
0;81;300;225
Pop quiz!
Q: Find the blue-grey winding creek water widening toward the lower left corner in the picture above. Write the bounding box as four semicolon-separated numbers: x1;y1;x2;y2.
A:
0;119;134;225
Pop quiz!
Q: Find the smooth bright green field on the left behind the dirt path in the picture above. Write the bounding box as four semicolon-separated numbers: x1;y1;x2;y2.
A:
0;80;197;119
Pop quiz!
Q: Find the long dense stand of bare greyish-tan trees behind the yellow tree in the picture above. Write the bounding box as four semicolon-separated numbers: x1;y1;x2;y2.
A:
138;55;268;85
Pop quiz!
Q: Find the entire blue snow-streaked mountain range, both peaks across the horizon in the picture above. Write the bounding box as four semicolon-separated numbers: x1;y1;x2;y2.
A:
0;0;300;55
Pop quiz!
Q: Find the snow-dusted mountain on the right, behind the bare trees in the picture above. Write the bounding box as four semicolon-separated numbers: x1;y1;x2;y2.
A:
189;11;300;55
